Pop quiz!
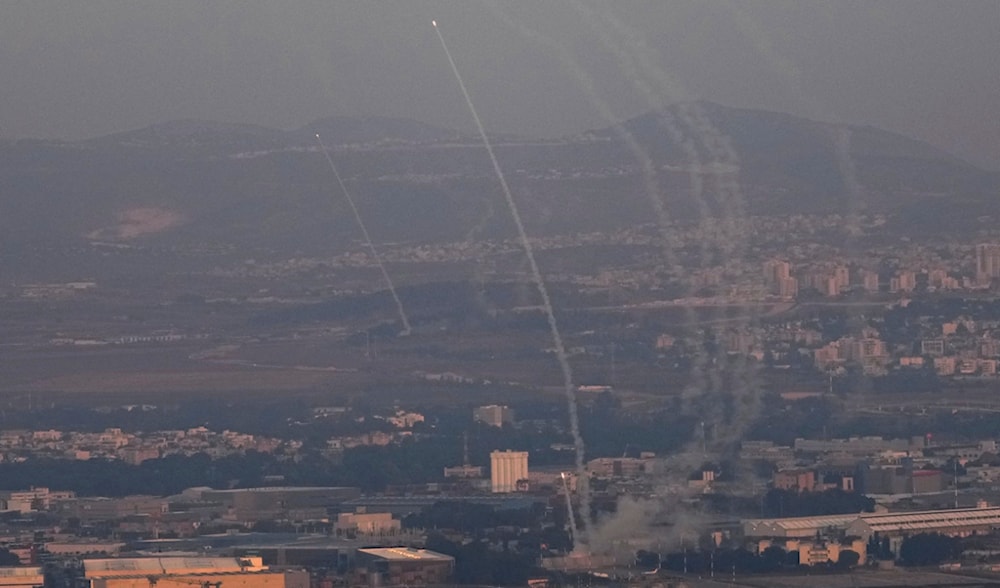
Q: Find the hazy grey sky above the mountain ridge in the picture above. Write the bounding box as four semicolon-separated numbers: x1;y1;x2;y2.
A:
0;0;1000;169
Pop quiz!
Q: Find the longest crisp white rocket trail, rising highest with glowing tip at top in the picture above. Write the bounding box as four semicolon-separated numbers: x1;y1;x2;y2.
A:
431;20;586;543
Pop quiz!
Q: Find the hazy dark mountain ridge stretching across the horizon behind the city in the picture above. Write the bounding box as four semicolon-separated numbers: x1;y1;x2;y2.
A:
0;102;1000;264
